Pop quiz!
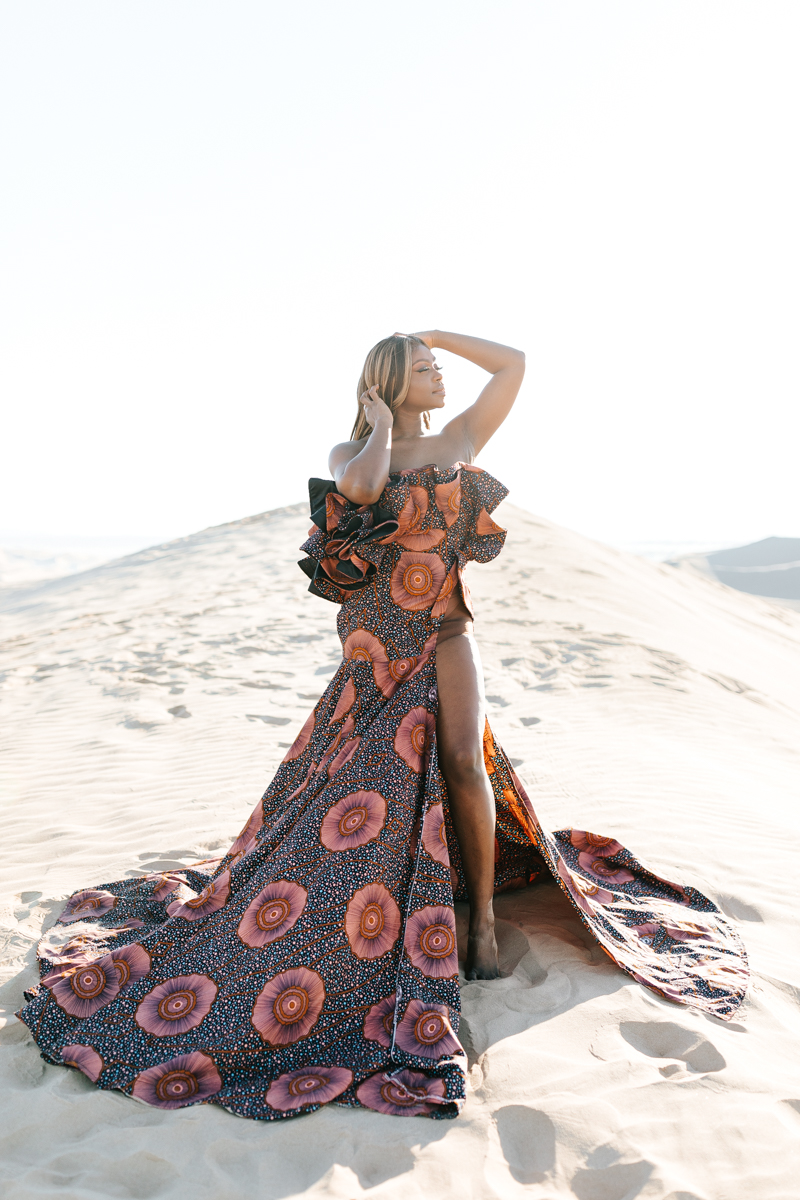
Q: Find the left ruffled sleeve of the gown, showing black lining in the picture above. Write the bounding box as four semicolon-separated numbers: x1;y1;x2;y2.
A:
299;479;398;604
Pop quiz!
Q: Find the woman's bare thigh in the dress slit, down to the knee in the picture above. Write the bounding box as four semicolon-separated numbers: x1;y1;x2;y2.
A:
437;632;486;778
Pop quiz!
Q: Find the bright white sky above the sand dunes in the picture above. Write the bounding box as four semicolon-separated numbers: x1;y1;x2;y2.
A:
0;0;800;546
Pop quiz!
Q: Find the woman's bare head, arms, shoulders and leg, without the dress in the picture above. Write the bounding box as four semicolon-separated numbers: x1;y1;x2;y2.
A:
329;331;525;979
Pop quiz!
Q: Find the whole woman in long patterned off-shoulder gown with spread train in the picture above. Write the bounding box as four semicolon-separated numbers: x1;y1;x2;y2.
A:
19;331;747;1120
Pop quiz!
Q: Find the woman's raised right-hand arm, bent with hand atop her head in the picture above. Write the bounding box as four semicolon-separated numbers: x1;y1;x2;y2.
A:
416;329;525;455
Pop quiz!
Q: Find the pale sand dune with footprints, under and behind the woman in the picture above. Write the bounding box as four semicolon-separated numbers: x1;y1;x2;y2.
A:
0;504;800;1200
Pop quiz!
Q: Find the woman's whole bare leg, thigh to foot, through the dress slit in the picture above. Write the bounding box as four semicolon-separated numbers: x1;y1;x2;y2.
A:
437;620;500;979
